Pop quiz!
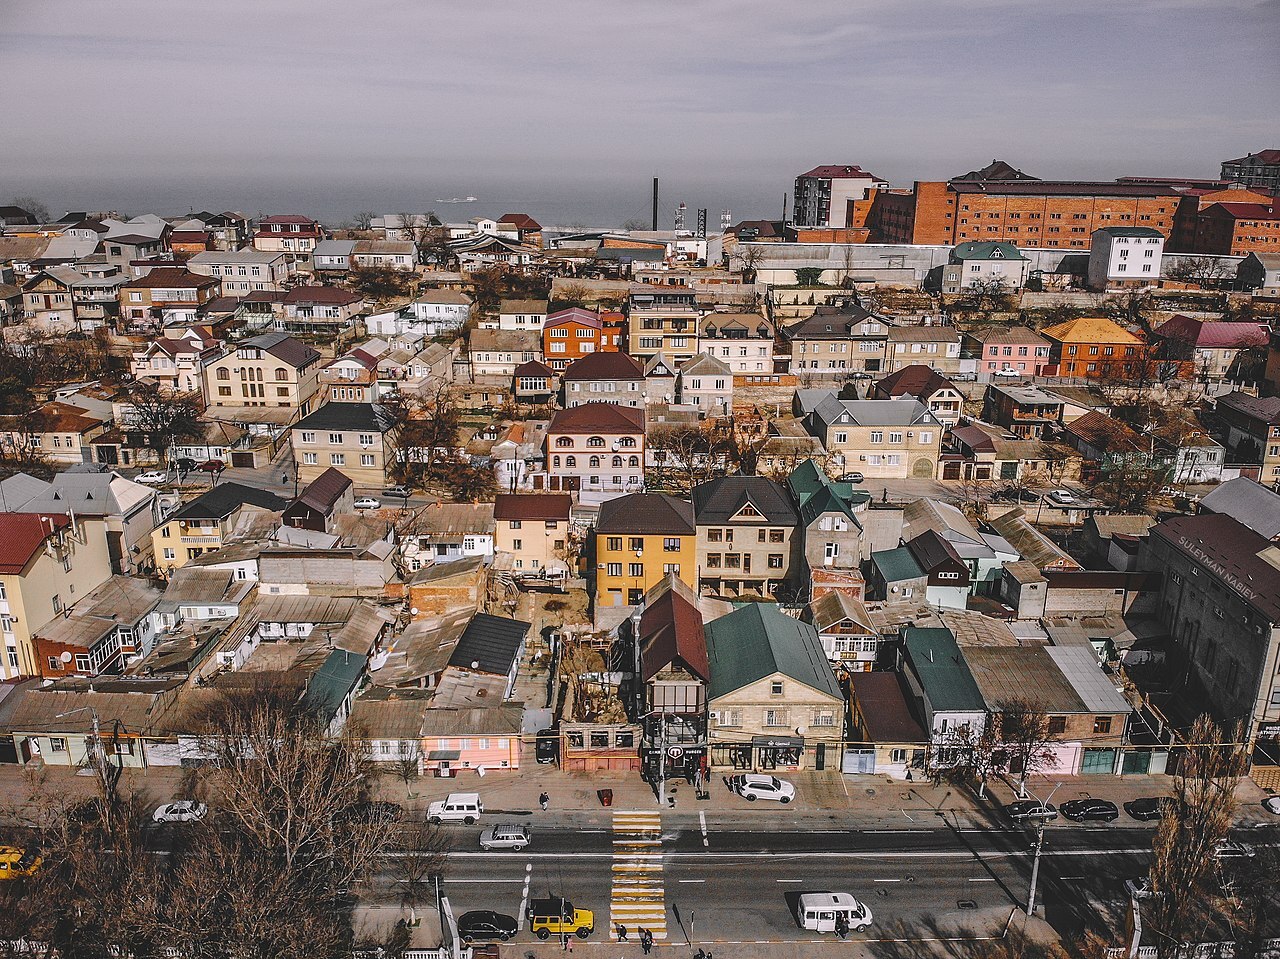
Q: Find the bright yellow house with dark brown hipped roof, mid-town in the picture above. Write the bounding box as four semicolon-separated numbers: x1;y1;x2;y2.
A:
594;493;698;607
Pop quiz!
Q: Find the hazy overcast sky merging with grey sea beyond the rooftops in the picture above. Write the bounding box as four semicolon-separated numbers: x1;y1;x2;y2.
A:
0;0;1280;225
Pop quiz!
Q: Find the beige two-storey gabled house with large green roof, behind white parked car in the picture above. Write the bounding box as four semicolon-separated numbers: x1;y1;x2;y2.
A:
704;603;847;771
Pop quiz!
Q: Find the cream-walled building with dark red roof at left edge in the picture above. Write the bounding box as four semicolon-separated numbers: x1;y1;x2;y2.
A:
0;513;111;679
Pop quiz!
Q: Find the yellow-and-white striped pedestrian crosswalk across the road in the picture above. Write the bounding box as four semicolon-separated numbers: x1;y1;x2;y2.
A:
609;812;667;942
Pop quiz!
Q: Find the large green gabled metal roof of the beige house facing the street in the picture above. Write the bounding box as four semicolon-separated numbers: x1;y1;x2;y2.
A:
704;603;845;699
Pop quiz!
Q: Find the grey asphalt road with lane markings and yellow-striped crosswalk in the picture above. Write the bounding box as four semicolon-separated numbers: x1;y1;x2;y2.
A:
372;819;1276;947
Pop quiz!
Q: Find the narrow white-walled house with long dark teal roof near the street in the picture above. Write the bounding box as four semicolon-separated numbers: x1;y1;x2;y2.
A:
902;626;987;766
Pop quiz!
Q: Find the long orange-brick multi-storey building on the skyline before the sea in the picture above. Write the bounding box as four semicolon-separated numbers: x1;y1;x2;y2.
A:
867;168;1180;250
